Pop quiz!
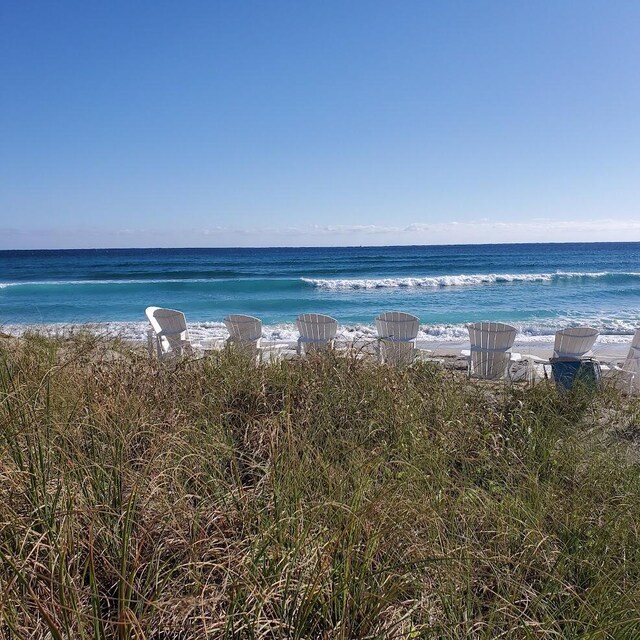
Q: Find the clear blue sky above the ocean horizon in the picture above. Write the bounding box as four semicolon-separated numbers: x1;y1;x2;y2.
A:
0;0;640;249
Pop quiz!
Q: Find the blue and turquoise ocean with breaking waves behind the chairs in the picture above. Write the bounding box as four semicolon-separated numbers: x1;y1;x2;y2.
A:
0;242;640;342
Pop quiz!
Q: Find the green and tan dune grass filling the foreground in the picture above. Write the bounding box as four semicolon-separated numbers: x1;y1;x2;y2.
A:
0;336;640;640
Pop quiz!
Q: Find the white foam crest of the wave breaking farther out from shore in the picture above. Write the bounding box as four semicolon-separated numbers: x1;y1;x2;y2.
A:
301;271;640;291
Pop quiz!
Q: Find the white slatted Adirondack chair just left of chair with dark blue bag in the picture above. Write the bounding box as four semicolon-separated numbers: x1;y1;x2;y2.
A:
462;322;522;380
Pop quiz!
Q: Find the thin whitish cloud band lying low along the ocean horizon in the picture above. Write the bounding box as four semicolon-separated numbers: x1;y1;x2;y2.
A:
0;216;640;249
